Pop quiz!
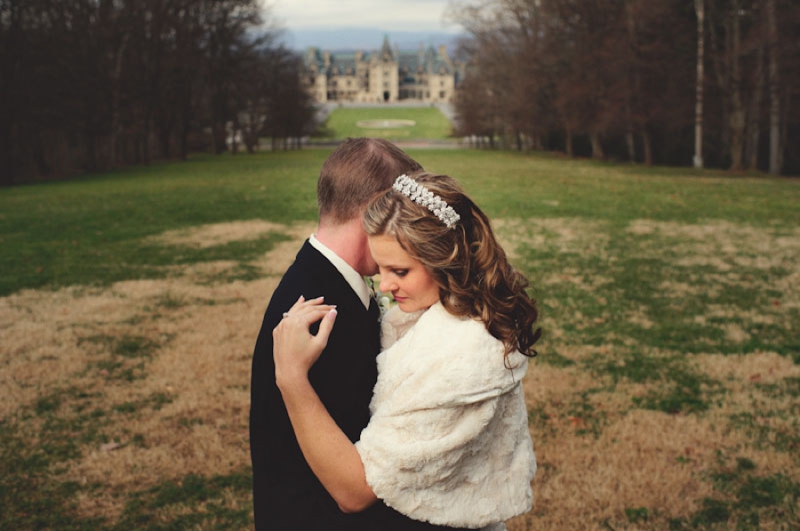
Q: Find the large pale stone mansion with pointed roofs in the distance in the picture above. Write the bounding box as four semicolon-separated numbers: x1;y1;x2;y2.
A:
303;36;464;103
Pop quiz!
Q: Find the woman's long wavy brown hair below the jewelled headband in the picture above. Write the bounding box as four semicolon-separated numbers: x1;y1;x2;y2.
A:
364;170;541;357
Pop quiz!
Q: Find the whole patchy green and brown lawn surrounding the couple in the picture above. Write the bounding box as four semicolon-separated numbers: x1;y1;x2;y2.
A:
0;150;800;531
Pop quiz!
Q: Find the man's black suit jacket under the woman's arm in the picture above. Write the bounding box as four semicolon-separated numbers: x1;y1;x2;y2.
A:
250;241;462;531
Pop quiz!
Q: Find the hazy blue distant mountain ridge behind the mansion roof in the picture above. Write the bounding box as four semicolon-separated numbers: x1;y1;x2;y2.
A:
284;28;461;52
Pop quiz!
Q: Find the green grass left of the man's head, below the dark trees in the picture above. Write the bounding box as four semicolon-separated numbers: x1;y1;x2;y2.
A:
0;150;325;295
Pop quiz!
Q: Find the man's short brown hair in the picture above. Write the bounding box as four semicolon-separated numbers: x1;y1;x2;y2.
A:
317;138;422;224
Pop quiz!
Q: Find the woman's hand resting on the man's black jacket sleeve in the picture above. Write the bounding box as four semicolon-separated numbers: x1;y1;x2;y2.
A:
272;297;336;386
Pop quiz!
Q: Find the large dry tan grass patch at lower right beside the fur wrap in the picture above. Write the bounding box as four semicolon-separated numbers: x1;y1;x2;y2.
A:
509;354;800;531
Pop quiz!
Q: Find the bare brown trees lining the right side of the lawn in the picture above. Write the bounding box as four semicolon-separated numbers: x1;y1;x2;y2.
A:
449;0;800;174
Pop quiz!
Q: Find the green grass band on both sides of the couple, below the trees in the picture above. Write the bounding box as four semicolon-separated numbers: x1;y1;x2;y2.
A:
0;150;800;295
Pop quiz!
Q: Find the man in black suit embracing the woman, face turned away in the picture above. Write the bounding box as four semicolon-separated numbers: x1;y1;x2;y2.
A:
250;138;444;531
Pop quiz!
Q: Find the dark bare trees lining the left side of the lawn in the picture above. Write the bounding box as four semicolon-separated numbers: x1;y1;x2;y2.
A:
0;0;315;184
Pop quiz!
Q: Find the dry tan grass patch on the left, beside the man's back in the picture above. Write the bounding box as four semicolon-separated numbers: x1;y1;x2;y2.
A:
0;222;313;518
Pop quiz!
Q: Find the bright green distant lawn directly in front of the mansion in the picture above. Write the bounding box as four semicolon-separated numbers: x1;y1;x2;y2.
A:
323;106;452;140
